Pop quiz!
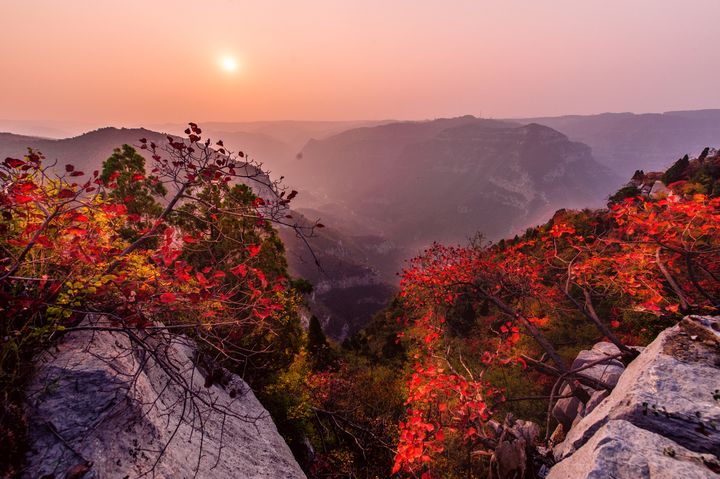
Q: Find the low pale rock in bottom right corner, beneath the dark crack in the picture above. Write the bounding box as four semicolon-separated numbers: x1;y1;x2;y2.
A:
547;420;718;479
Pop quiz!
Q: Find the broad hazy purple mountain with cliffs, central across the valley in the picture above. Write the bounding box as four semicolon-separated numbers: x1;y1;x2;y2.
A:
295;117;619;252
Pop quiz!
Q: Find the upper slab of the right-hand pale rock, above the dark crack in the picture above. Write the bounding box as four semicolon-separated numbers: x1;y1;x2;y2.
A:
554;316;720;462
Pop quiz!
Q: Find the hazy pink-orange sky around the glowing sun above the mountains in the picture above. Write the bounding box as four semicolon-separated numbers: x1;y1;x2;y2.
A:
0;0;720;125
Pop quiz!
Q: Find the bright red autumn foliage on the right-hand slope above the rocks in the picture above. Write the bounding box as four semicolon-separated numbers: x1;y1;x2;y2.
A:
392;189;720;477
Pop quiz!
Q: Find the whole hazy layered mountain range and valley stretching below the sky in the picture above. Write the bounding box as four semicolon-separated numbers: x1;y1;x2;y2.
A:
0;110;720;339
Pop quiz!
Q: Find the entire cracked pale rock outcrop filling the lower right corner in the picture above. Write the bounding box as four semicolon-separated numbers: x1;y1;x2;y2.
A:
547;316;720;479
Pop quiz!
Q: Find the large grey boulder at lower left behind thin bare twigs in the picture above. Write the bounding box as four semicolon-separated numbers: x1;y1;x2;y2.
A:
24;316;305;479
